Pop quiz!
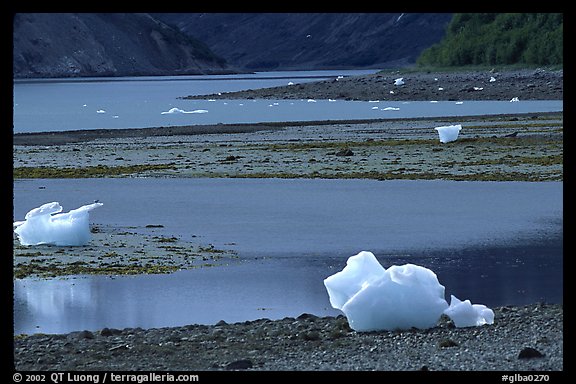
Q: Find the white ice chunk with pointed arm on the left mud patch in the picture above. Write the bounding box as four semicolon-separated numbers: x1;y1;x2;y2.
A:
14;202;103;246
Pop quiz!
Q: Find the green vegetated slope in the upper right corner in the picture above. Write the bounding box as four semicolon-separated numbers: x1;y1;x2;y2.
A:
417;13;564;67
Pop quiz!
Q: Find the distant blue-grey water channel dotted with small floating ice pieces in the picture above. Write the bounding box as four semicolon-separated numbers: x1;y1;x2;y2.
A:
13;70;563;133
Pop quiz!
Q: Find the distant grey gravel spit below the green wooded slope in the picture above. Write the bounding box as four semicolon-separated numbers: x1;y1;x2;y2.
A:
184;68;564;101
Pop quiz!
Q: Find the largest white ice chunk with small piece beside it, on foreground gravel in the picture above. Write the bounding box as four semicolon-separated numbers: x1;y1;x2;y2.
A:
324;251;494;332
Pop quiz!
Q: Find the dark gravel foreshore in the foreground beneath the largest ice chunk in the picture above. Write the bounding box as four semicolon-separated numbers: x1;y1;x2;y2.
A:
14;304;563;372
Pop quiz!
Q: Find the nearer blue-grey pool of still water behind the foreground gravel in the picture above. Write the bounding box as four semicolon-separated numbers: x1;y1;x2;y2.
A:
14;179;563;333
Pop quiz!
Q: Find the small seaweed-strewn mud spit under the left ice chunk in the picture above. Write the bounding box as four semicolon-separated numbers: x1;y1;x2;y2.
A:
13;224;237;279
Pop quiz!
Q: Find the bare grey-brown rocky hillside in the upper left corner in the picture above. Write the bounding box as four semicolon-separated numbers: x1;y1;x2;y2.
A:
13;13;229;78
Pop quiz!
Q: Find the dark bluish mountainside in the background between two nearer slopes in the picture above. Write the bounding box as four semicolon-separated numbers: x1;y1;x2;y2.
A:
154;13;452;71
